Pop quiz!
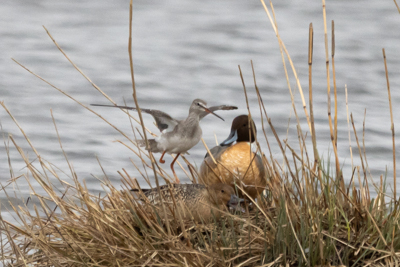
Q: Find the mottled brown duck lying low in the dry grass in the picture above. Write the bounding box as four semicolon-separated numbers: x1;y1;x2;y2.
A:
131;183;243;222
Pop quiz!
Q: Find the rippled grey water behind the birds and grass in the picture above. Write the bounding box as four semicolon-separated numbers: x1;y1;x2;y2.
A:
0;0;400;219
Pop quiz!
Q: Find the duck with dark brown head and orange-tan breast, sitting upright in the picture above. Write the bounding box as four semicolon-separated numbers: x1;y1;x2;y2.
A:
199;115;267;198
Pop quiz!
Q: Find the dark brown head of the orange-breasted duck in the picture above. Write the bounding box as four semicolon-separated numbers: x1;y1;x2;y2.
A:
220;115;257;146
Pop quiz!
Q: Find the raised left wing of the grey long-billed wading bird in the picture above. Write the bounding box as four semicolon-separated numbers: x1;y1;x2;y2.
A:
90;104;179;132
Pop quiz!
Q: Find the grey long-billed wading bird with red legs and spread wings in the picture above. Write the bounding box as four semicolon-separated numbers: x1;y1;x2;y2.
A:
91;99;237;183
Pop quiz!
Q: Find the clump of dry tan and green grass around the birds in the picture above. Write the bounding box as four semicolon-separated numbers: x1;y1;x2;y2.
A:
0;2;400;266
